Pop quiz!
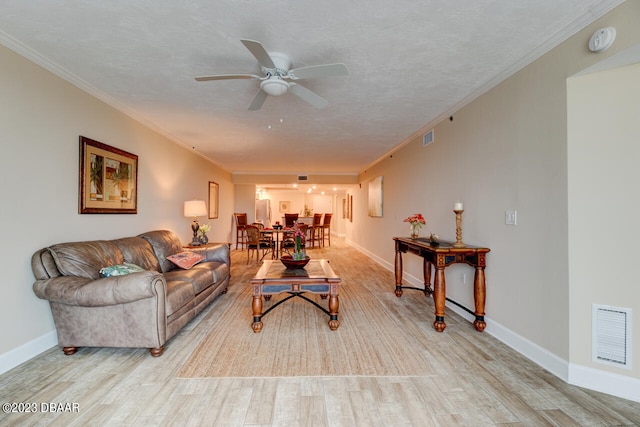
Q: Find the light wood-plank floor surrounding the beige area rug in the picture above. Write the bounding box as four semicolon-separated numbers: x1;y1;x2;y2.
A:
0;239;640;426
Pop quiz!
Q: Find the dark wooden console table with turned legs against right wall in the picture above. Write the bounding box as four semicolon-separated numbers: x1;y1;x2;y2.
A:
393;237;490;332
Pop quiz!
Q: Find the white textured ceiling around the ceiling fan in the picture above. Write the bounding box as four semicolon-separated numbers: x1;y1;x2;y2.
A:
0;0;622;174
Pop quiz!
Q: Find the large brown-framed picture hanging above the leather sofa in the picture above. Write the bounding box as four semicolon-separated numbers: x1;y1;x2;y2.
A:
78;136;138;214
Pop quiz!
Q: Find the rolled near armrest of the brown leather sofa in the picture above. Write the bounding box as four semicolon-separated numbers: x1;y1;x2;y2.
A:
33;271;167;307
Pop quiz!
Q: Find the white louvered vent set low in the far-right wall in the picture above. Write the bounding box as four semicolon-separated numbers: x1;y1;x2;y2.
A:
591;304;632;369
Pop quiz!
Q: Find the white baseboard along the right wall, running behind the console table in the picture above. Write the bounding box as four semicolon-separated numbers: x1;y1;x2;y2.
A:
347;241;640;402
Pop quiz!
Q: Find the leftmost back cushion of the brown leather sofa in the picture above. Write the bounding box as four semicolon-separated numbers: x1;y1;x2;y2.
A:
48;240;124;279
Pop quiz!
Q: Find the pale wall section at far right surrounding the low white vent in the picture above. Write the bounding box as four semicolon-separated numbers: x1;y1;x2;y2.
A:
568;64;640;378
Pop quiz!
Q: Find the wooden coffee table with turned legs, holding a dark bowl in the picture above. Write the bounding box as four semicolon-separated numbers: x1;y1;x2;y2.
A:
251;259;341;333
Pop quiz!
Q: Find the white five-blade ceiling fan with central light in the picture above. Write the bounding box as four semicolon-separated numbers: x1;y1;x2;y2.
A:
196;40;349;110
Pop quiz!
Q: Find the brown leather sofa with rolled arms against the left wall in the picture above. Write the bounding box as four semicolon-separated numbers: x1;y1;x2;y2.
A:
31;230;230;356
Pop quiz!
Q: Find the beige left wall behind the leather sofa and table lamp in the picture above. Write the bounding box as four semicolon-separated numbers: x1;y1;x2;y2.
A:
0;42;234;364
